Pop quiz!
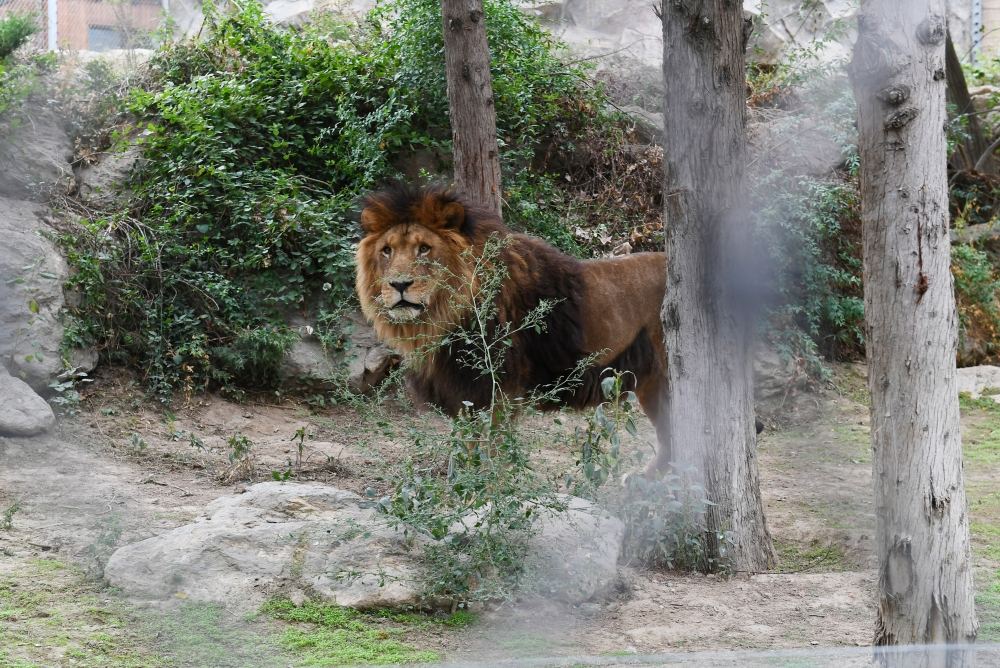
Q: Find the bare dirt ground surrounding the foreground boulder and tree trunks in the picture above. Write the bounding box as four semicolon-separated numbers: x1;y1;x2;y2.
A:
0;365;1000;667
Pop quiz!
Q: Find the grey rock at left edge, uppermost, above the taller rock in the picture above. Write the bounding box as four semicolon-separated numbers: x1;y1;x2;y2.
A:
0;98;73;202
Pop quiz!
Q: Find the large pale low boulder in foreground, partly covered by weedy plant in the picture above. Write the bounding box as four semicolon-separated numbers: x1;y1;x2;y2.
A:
104;482;623;610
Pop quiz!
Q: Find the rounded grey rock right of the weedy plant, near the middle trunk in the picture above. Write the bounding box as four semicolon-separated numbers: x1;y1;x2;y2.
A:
528;494;625;604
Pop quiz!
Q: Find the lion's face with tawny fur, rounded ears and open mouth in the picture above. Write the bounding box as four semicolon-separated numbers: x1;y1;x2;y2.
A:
357;185;471;351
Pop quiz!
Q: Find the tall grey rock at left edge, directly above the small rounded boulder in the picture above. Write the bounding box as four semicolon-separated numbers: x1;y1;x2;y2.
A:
0;197;96;394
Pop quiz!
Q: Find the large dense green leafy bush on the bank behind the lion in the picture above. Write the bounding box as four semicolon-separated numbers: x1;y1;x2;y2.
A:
63;0;616;397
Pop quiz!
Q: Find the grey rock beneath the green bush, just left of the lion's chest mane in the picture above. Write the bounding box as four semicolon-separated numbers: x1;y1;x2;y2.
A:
279;313;400;393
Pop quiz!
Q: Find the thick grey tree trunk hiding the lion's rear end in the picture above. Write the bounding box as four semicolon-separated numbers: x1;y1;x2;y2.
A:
658;0;775;571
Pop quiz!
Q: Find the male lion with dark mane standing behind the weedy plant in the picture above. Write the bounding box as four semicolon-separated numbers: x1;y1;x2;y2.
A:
356;185;670;469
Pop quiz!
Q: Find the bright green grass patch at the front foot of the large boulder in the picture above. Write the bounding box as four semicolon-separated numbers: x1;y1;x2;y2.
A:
261;599;444;666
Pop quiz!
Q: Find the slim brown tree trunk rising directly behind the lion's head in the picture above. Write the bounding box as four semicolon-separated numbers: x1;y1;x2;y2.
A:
441;0;500;214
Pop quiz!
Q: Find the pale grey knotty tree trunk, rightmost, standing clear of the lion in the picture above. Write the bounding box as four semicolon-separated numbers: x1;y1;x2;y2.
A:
851;0;976;666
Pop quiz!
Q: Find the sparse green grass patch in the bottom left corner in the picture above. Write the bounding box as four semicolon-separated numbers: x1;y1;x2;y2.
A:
0;559;165;668
